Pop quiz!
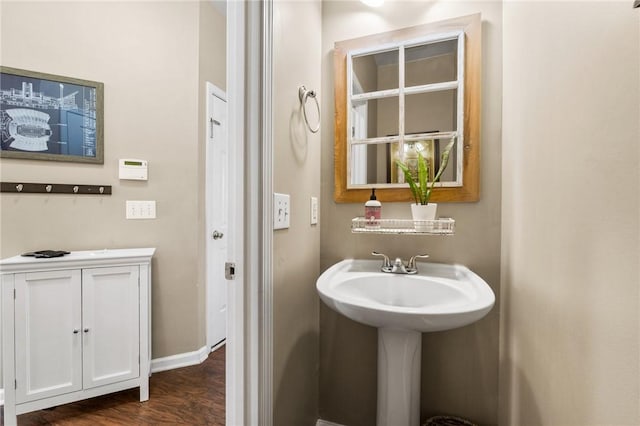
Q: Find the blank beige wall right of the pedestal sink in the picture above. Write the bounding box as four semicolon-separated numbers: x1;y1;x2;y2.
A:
500;1;640;426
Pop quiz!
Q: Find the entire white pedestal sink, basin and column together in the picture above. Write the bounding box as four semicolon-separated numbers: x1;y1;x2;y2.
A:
316;259;495;426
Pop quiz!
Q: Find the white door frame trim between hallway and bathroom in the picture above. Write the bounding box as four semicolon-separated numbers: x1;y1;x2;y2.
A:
226;0;273;426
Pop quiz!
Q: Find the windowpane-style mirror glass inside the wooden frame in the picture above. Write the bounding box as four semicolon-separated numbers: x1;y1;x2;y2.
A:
347;32;464;187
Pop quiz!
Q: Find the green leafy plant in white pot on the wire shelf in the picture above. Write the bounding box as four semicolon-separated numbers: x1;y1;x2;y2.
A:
396;138;456;230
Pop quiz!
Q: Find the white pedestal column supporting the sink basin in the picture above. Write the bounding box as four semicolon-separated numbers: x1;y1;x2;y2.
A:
377;328;422;426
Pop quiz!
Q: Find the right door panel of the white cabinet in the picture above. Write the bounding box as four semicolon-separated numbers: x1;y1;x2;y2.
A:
82;266;140;389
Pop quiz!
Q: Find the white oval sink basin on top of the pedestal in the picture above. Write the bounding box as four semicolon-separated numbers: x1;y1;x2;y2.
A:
316;259;495;332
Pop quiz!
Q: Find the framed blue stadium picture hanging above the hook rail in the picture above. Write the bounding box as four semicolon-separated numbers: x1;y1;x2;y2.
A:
0;66;104;164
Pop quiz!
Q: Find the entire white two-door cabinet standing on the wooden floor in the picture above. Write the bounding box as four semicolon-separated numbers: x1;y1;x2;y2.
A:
0;249;155;425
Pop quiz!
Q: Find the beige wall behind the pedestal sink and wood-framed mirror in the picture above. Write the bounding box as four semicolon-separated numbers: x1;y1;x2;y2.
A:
320;1;502;426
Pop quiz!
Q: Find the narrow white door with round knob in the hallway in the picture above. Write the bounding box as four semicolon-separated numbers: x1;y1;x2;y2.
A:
206;83;230;348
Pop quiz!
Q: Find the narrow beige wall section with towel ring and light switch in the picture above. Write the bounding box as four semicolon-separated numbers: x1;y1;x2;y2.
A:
273;0;320;426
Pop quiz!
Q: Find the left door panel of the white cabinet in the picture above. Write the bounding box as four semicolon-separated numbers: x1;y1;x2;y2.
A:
15;270;82;403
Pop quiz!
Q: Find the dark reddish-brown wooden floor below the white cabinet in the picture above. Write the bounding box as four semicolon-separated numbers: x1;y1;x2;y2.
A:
0;346;225;426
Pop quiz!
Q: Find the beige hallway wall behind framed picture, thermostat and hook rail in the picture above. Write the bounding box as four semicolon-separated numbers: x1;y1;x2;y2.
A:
0;1;225;384
